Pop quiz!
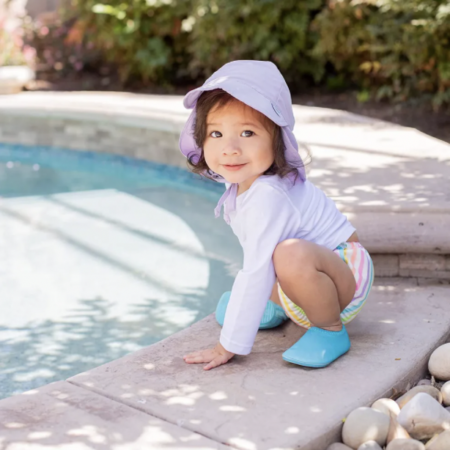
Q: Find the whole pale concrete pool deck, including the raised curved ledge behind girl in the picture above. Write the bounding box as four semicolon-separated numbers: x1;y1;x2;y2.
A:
0;93;450;450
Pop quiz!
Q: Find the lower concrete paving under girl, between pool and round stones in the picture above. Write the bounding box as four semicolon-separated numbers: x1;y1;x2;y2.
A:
0;278;450;450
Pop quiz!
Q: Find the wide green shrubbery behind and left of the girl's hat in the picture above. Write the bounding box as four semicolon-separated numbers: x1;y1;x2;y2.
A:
66;0;324;84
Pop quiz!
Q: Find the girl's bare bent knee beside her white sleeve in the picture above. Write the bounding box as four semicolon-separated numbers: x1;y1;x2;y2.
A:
273;239;314;278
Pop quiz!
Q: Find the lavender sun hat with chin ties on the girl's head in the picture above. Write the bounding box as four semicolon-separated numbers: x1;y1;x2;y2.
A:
179;60;306;223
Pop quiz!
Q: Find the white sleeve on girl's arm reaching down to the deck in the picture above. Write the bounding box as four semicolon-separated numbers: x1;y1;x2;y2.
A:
220;184;298;355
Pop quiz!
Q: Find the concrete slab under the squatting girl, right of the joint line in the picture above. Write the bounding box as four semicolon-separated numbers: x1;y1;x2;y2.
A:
59;279;450;450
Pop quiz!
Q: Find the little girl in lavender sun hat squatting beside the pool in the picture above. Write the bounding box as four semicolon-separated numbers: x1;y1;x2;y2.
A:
180;61;373;370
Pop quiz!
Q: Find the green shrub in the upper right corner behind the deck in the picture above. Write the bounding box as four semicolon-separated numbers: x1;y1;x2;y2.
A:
313;0;450;107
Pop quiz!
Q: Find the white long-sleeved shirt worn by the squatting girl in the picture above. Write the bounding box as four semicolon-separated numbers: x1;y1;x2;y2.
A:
220;175;355;355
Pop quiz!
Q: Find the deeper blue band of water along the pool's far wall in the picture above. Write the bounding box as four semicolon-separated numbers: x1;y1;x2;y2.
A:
0;144;224;200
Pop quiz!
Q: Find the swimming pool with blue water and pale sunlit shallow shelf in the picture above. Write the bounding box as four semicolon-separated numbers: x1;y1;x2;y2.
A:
0;144;242;398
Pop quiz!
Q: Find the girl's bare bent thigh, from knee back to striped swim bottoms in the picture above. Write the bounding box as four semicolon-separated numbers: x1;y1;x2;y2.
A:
273;239;356;311
